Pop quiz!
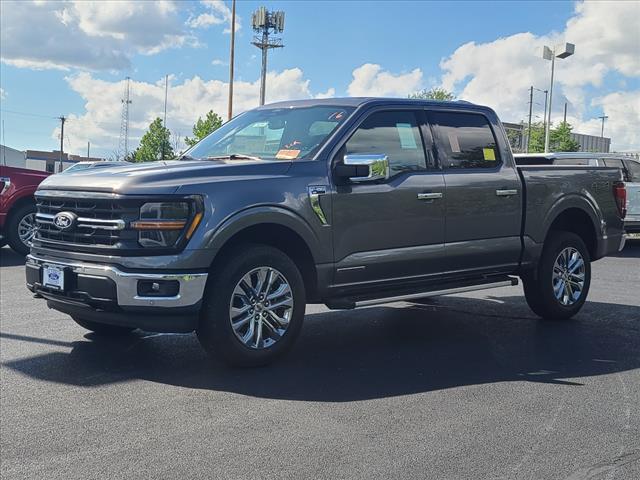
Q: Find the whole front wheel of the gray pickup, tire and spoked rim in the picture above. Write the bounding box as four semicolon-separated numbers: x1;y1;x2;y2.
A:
197;245;306;367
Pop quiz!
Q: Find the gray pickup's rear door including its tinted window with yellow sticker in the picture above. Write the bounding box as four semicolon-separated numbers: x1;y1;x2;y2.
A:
428;110;523;273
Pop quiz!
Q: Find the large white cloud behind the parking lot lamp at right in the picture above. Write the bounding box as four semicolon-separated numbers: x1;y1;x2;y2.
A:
440;1;640;149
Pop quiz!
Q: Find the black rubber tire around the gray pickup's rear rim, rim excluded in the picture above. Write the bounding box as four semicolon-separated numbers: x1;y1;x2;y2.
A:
522;231;591;320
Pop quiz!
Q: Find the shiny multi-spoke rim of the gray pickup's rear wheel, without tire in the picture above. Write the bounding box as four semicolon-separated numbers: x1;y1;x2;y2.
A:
553;247;586;307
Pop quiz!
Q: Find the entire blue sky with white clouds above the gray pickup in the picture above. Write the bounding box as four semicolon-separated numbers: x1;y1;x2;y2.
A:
0;1;640;156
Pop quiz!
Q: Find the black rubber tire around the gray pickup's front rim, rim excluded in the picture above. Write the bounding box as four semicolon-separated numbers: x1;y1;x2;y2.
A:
196;244;306;367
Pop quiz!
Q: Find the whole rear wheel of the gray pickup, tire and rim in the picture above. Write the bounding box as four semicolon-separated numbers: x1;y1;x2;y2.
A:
522;232;591;320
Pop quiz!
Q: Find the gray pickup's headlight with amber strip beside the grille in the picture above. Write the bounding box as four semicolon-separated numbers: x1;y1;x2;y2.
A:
131;202;202;248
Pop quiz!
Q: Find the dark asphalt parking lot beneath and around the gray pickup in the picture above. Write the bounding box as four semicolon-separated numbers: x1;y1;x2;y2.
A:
0;242;640;480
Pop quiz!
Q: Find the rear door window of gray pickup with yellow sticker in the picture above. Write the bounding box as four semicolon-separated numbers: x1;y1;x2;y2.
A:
429;112;501;169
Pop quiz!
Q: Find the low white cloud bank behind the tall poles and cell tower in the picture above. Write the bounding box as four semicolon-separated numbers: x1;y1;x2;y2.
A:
58;68;334;154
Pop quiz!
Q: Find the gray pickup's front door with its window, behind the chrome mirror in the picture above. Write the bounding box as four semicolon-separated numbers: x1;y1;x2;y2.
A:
332;109;445;286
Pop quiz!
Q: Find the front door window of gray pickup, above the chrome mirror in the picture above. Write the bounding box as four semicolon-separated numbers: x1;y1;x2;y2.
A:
345;111;426;176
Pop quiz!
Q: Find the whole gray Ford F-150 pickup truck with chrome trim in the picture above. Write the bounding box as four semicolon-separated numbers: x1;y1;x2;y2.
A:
26;98;625;365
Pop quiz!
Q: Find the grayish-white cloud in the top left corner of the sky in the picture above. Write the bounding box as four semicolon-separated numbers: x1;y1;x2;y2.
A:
0;0;195;70
